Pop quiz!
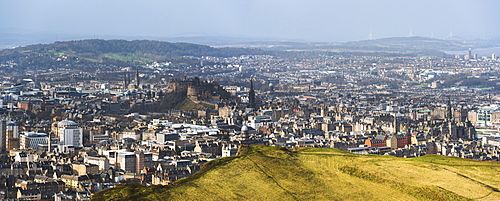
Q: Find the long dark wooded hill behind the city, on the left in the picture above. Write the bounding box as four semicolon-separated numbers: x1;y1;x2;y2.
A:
0;39;266;68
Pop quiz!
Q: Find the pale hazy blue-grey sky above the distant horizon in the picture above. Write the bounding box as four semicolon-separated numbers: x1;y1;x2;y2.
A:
0;0;500;42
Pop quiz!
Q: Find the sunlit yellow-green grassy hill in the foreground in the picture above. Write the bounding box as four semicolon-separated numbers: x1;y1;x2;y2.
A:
93;146;500;200
